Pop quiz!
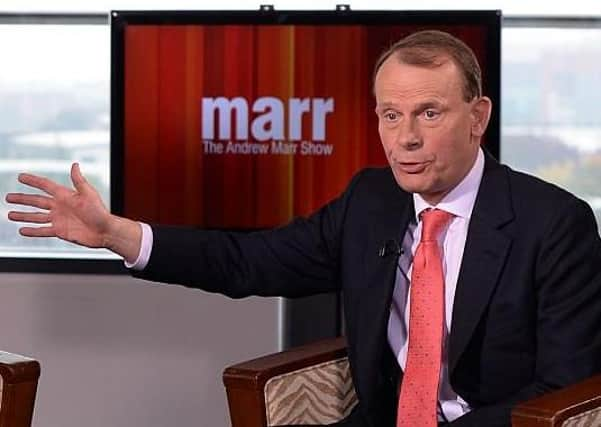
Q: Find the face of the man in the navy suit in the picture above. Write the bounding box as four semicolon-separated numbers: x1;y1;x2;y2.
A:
374;55;491;204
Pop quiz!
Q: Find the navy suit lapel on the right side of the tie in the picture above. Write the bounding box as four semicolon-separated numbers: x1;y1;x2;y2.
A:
449;156;513;373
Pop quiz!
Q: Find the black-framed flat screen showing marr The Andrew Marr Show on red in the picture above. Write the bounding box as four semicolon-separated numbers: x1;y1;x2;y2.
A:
111;8;501;230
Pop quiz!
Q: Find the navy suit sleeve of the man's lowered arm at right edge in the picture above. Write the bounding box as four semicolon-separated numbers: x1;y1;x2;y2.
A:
450;199;601;427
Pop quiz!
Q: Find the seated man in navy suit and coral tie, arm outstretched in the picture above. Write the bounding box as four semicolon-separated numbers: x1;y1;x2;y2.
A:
7;31;601;427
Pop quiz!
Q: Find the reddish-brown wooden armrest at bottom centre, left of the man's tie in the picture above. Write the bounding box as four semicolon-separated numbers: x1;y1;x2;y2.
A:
223;337;346;427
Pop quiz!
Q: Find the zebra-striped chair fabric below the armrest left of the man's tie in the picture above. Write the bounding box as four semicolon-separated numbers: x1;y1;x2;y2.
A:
265;357;357;427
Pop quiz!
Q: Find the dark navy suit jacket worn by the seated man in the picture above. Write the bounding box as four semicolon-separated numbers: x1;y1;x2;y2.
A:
134;156;601;427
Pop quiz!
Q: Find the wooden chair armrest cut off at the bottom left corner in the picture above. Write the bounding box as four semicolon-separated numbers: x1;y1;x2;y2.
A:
0;352;40;427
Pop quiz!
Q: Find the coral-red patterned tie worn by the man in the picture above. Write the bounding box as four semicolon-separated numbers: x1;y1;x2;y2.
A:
397;209;452;427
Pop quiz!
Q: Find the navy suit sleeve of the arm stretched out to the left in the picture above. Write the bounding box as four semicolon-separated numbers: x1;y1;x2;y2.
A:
132;171;359;298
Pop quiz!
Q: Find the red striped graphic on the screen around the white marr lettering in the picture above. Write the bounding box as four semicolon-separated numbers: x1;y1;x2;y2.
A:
124;25;487;229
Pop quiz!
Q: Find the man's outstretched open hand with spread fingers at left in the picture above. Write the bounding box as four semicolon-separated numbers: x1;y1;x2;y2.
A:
6;163;111;248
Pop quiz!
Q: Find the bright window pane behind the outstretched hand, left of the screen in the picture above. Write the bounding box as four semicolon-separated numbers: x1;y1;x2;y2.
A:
0;24;115;258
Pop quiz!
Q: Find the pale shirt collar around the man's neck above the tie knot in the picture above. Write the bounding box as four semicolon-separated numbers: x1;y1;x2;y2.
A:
413;148;484;223
